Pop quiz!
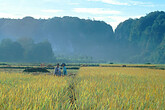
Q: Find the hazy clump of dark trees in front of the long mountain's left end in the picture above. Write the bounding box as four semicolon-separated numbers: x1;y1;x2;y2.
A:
0;39;55;62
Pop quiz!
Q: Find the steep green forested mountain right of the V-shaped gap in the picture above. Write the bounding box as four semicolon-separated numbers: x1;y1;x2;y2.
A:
115;11;165;63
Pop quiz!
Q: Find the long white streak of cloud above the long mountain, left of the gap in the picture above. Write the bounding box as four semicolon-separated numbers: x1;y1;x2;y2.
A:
73;8;120;14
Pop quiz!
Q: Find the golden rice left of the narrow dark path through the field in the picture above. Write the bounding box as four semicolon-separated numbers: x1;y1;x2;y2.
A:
0;73;70;110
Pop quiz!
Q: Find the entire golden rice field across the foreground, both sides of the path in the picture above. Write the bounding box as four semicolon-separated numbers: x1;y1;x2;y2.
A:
0;67;165;110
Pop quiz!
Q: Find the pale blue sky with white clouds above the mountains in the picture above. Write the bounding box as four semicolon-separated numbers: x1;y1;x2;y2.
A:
0;0;165;29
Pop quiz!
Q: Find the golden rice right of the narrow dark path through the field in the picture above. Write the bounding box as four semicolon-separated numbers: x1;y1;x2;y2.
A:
76;67;165;110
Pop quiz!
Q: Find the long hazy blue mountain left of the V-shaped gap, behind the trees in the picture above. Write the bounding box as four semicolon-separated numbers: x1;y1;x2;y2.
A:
0;16;114;57
